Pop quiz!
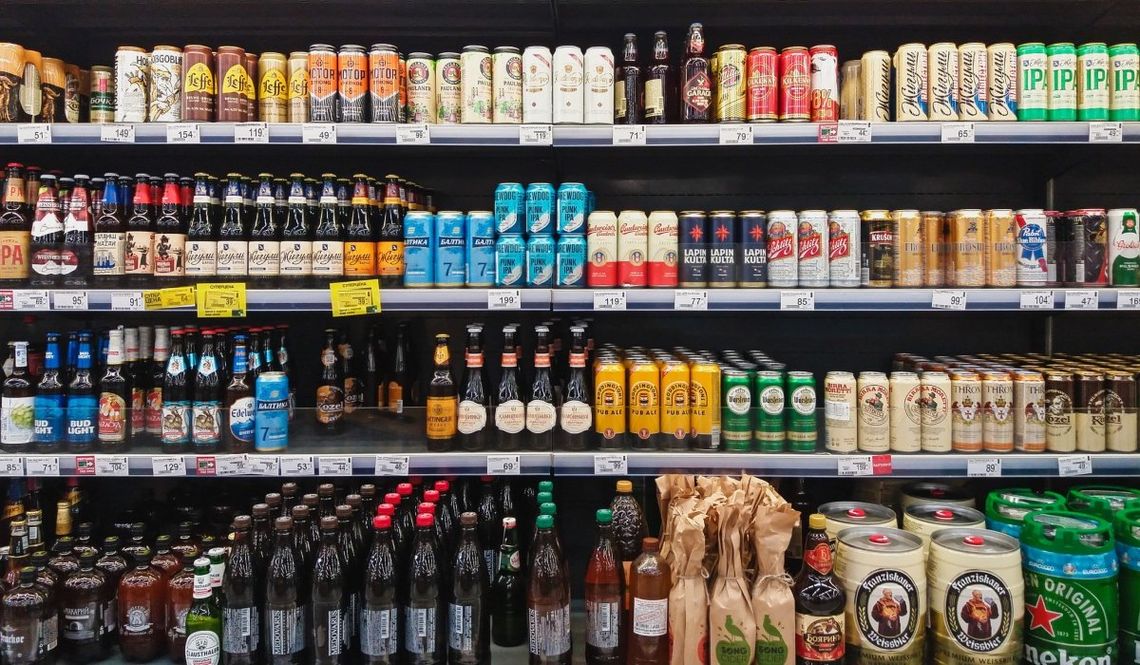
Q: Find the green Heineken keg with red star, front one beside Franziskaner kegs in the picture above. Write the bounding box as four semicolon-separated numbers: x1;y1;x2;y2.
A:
1021;510;1117;665
